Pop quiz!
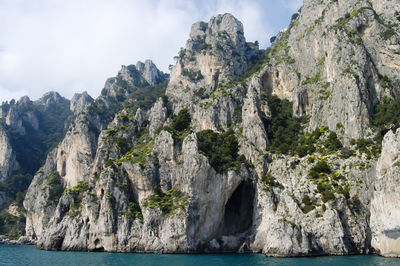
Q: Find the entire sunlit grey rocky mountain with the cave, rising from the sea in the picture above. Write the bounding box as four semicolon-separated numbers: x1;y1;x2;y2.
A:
3;0;400;257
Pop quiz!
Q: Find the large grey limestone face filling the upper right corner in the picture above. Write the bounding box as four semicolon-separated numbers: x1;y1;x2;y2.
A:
263;0;400;141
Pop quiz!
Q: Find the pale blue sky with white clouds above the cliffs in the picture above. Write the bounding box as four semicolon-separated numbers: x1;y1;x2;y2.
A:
0;0;303;102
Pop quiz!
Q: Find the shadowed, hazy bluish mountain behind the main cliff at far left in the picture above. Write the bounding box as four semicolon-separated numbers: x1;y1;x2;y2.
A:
0;92;80;237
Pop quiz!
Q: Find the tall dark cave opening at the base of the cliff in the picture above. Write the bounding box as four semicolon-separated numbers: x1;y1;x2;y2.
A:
221;179;255;236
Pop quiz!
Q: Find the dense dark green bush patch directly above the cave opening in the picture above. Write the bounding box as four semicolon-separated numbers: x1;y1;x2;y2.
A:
197;128;246;173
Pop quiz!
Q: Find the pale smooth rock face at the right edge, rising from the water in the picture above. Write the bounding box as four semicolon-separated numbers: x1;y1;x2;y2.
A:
370;129;400;257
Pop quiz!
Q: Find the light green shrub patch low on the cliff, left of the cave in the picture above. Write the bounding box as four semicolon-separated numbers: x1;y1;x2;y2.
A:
144;188;188;215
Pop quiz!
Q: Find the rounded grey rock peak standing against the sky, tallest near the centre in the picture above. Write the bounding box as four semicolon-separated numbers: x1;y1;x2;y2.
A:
167;14;259;101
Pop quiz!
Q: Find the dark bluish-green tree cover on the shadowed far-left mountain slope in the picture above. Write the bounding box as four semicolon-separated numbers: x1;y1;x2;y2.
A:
0;96;72;209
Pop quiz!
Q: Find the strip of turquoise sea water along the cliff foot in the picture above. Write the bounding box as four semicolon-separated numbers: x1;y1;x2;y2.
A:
0;245;400;266
